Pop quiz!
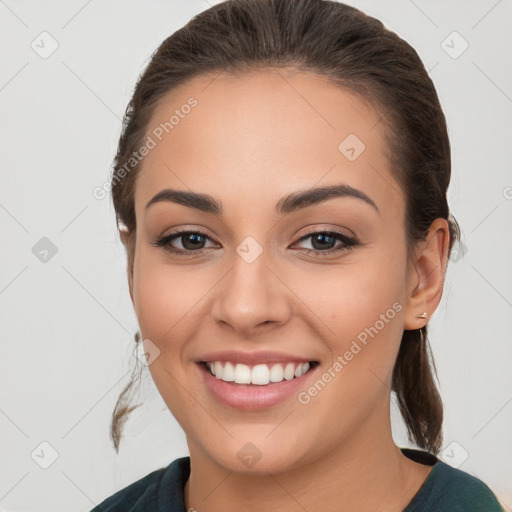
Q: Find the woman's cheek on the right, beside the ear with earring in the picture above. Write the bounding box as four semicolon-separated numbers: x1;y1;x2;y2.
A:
294;248;405;396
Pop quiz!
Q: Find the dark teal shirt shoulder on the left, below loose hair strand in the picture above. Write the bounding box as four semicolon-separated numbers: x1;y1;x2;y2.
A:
90;457;188;512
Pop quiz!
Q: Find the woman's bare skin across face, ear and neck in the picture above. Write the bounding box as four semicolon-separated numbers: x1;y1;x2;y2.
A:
122;68;449;512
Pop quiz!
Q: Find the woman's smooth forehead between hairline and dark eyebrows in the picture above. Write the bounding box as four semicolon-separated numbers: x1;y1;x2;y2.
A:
135;68;403;220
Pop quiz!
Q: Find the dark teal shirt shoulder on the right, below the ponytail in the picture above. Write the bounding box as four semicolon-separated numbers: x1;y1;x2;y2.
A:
405;461;504;512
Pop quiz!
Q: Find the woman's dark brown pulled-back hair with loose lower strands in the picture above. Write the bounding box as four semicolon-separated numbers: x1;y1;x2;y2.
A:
110;0;460;454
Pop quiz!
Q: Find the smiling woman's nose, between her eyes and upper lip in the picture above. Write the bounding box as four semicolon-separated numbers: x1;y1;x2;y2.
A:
212;251;292;336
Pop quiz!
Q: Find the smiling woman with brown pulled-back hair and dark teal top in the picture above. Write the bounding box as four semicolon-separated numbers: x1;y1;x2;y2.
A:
94;0;502;512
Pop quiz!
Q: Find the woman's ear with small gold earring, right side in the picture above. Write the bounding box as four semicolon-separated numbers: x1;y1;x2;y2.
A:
404;218;450;330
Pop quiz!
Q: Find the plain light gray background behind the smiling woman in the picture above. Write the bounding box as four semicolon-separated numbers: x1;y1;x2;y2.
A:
0;0;512;512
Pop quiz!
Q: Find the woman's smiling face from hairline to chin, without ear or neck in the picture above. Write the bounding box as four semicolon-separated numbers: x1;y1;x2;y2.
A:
131;69;416;472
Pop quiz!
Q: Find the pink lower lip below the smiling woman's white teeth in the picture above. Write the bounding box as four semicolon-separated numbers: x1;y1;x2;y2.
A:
198;364;317;410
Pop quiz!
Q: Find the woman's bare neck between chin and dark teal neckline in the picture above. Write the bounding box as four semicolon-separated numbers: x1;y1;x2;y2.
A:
185;407;431;512
